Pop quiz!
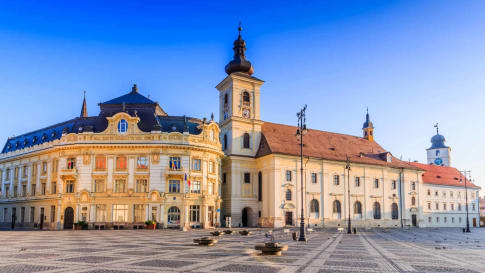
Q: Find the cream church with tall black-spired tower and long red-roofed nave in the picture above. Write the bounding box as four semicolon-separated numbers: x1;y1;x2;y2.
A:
216;29;423;227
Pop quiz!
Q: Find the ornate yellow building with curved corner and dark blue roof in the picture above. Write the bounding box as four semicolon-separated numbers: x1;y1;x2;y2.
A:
0;85;223;229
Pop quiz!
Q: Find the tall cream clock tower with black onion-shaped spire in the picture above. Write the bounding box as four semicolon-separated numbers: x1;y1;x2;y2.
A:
216;26;264;227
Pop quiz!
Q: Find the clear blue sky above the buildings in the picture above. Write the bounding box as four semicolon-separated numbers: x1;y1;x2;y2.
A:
0;0;485;191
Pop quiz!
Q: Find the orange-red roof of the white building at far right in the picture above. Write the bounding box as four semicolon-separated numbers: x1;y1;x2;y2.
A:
410;162;480;189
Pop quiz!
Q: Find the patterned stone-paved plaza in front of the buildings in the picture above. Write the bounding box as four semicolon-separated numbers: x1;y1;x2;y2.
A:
0;228;485;273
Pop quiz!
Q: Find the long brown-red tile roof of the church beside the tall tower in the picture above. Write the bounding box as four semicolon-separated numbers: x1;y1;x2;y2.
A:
256;122;419;170
